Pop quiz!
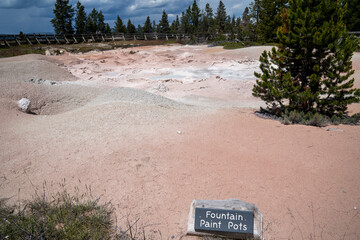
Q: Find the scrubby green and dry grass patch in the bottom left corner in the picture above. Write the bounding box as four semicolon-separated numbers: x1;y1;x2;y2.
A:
0;190;116;239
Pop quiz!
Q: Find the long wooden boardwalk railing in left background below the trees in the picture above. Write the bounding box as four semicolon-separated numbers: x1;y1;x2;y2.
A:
0;33;194;47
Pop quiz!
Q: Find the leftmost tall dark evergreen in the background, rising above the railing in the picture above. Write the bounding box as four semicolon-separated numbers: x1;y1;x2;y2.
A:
51;0;74;34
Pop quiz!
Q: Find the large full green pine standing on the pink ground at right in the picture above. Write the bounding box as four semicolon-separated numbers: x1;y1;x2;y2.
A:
253;0;360;116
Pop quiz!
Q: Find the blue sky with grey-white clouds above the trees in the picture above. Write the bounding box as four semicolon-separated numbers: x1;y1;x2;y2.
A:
0;0;252;34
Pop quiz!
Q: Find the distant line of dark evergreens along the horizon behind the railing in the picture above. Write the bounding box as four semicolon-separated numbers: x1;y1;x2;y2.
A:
51;0;360;42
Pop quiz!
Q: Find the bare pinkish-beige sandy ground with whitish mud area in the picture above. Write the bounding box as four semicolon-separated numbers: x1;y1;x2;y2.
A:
0;45;360;239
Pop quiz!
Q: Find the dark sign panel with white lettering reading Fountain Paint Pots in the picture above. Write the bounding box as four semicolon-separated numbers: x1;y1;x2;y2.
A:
195;208;254;234
